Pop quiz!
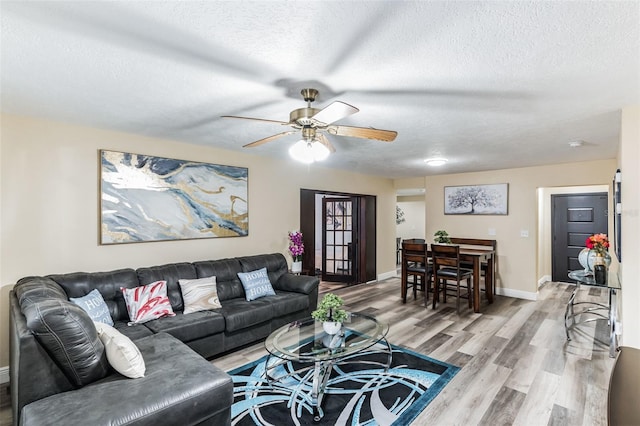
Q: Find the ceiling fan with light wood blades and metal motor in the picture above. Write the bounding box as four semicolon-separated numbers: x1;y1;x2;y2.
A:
222;88;398;152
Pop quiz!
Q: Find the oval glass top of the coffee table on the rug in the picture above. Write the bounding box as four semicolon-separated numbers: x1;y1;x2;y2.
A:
264;313;389;362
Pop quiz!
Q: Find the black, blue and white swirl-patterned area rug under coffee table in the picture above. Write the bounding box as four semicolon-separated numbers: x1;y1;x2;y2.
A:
229;345;460;426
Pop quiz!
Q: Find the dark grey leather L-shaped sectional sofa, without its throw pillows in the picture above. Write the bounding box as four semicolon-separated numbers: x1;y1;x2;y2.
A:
10;253;319;426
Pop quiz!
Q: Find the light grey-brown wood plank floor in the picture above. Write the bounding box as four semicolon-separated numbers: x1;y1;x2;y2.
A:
0;278;613;426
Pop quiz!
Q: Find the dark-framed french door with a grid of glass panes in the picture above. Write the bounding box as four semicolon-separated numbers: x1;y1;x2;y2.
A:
322;197;358;283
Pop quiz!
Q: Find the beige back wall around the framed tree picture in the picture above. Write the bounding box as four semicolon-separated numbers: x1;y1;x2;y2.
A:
426;160;616;299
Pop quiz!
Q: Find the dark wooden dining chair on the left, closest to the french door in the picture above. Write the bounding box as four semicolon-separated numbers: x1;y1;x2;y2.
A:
401;241;433;306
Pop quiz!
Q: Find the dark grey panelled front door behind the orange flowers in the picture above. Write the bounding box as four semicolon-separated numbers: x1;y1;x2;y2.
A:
551;192;609;282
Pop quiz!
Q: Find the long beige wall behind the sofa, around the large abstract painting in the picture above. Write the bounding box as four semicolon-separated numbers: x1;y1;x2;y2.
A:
0;115;396;366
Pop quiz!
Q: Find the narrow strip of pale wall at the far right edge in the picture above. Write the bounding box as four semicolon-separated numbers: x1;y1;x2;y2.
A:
618;105;640;348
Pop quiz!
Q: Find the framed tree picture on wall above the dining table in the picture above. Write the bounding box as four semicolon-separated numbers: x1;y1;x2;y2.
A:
444;183;509;215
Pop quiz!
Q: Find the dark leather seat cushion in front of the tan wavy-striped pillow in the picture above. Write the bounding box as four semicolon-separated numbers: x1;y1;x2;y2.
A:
145;311;225;342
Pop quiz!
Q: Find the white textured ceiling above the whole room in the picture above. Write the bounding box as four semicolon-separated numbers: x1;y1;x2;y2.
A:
0;1;640;178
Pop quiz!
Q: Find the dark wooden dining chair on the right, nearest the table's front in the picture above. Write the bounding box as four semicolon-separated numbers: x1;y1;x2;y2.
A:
431;244;473;314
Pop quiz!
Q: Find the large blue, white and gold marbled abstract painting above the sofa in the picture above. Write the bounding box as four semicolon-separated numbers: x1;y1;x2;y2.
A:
100;150;249;244
